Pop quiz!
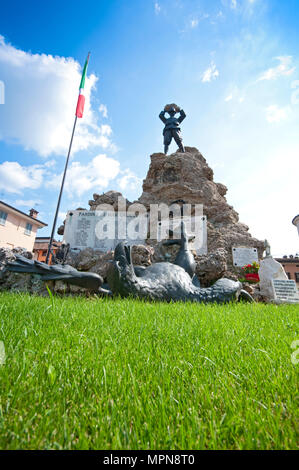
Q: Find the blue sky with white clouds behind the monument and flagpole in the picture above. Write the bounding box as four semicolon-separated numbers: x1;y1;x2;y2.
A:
0;0;299;255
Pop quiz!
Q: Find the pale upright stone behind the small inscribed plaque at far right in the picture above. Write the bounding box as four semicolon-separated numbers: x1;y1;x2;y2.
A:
259;256;288;300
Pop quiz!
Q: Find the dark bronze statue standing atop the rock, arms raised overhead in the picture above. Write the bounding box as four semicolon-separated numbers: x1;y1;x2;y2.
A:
159;103;186;155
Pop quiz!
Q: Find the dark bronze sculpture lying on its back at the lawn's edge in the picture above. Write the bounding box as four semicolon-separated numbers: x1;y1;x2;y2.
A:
107;222;253;303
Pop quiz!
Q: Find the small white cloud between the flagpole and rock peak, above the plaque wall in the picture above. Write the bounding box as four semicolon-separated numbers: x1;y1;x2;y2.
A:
47;154;120;197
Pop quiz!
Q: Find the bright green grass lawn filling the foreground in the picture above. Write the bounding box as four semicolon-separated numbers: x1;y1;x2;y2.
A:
0;293;299;449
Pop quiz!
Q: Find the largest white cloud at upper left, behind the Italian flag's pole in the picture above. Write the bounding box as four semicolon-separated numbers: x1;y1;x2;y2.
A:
0;36;111;156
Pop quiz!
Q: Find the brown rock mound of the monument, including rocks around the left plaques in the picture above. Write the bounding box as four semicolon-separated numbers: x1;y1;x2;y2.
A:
55;147;265;286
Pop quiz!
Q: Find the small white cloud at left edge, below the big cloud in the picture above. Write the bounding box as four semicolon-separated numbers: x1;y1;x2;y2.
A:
0;162;45;194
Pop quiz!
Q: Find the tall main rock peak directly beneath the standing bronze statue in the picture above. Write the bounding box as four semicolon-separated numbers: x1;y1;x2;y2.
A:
138;147;264;285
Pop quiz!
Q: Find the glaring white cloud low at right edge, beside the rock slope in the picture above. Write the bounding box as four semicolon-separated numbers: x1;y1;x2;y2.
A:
231;143;299;256
